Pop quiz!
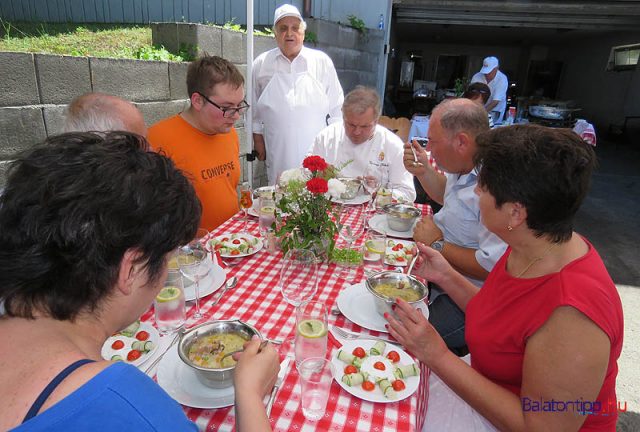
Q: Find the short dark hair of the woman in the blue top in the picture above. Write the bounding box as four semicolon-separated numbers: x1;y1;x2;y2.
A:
0;132;201;321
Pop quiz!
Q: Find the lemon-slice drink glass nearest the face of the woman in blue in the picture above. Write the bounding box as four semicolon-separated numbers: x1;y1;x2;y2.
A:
154;270;187;335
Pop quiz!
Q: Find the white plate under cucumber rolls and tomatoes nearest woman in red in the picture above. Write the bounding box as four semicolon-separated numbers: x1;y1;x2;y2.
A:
331;339;420;403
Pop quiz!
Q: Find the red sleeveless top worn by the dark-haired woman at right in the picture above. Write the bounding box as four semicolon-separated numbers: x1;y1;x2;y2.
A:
465;239;624;432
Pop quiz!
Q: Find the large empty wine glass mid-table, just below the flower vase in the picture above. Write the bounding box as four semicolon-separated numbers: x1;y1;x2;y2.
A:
279;249;318;307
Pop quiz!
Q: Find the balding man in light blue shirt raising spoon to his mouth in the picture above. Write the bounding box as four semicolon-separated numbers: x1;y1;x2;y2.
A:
403;99;506;352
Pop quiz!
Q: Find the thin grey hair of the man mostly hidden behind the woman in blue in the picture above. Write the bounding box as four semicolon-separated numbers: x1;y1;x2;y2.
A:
62;93;128;132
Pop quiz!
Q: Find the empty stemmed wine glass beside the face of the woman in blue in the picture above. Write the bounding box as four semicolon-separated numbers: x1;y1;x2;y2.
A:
178;228;211;319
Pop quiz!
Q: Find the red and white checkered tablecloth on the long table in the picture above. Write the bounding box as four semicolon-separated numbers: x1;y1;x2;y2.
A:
142;205;432;432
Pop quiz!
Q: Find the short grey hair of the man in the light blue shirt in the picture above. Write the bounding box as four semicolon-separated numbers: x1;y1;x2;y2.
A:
431;98;489;138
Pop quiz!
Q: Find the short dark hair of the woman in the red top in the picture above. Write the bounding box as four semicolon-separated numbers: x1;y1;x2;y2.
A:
476;125;596;242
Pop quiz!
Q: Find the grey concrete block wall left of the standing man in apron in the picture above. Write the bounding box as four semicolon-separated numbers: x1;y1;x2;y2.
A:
0;23;276;189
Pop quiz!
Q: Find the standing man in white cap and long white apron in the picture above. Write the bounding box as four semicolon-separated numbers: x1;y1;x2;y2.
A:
253;4;344;184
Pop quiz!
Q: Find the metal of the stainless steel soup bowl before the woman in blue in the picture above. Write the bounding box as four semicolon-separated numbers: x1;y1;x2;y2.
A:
178;320;262;388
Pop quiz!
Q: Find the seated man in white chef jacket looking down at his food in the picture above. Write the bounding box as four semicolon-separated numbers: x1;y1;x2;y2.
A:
310;86;416;202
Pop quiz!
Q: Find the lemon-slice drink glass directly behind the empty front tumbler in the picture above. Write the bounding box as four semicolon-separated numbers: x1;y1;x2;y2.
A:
295;301;328;366
